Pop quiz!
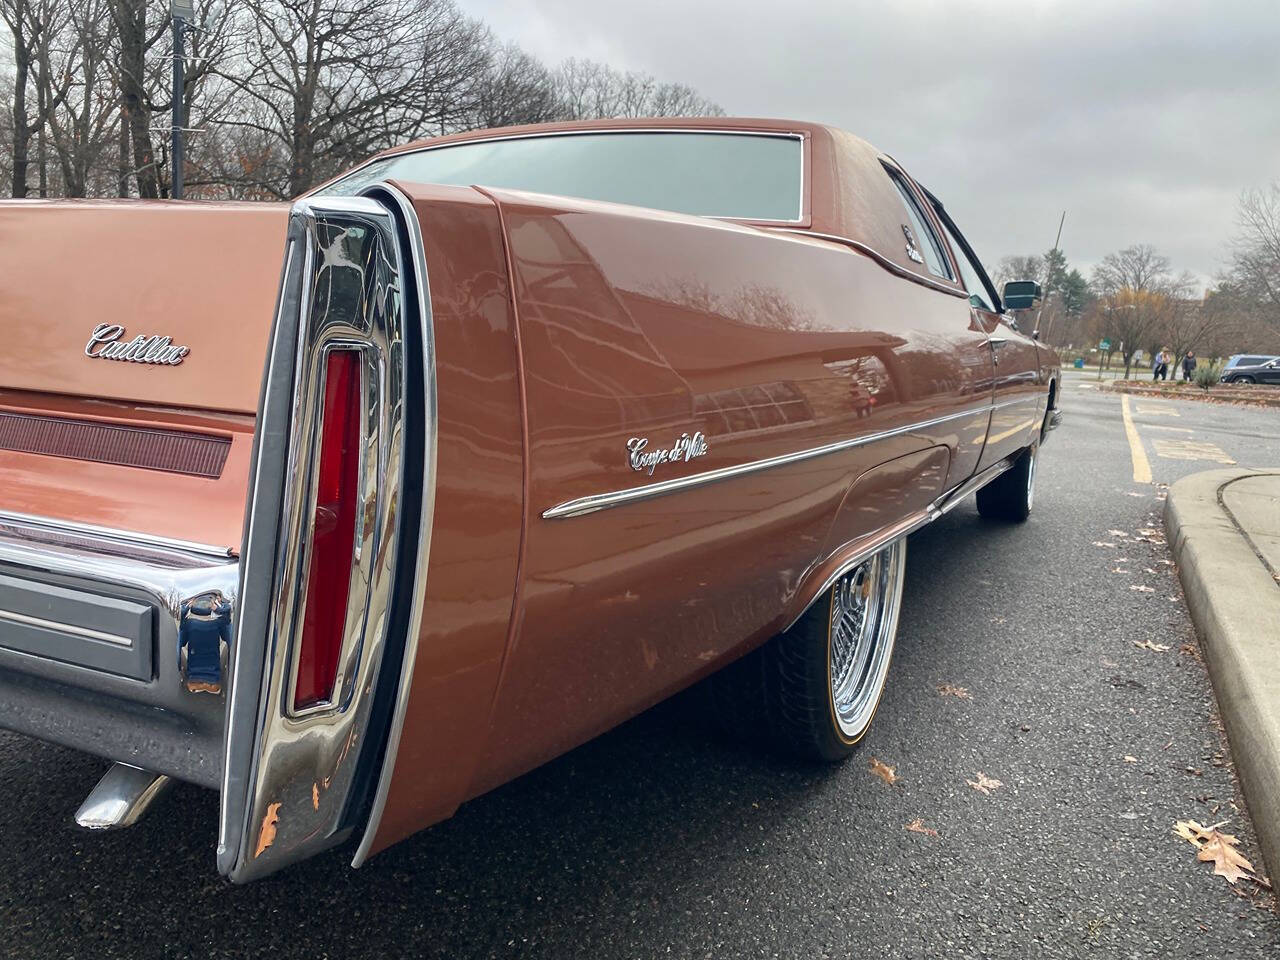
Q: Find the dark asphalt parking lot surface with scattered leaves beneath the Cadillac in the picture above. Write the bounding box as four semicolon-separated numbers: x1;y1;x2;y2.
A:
0;376;1280;959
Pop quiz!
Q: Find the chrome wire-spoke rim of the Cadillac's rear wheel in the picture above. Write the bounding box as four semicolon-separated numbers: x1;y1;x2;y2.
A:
828;543;902;739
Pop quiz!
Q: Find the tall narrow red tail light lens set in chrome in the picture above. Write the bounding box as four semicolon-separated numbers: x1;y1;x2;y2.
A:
293;349;362;709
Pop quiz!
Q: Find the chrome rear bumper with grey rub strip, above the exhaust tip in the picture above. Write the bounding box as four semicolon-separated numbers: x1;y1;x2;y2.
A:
0;512;239;787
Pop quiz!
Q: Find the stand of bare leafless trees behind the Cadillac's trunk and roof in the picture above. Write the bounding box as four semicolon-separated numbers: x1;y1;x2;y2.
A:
0;0;721;200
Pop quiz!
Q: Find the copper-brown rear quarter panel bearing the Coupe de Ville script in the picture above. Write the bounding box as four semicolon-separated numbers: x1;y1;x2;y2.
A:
465;191;991;794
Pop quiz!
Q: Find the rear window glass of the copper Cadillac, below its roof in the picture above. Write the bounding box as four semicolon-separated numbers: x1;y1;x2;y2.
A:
317;132;804;223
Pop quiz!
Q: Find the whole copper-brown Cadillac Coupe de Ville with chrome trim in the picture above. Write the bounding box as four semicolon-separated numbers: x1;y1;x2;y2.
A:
0;119;1059;881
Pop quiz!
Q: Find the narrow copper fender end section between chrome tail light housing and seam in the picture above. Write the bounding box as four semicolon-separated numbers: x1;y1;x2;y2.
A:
374;184;524;849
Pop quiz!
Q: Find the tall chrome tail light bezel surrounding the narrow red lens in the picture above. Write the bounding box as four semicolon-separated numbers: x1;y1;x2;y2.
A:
218;184;435;881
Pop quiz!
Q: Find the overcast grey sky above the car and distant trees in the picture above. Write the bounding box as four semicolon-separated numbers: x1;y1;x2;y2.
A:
460;0;1280;289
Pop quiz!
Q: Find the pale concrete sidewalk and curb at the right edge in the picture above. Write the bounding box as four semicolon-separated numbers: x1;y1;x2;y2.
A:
1165;467;1280;878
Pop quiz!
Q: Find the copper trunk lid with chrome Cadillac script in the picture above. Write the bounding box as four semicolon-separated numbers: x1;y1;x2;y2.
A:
0;201;289;413
